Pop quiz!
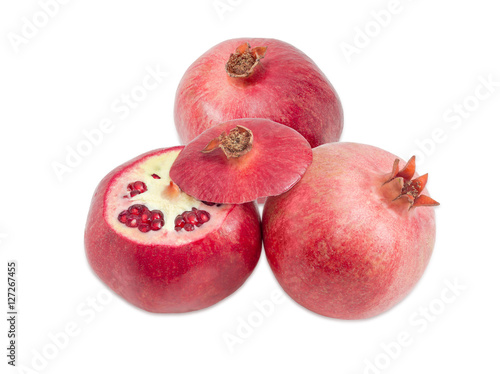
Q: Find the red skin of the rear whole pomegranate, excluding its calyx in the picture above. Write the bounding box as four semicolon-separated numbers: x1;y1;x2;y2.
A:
174;38;343;147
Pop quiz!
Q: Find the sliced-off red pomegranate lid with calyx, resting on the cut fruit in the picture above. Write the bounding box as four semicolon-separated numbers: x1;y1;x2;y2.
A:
170;118;312;204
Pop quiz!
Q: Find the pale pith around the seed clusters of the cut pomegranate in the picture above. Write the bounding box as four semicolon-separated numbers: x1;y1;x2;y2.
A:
105;150;231;245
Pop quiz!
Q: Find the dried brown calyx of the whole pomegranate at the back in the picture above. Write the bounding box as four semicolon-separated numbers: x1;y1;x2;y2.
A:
226;42;267;78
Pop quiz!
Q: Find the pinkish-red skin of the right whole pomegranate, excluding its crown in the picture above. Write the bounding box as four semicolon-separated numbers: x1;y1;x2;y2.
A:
263;143;435;319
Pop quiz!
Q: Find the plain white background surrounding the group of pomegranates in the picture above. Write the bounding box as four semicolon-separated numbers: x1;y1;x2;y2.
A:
0;0;500;374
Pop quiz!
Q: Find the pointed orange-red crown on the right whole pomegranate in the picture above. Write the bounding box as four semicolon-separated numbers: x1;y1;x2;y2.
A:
384;156;439;209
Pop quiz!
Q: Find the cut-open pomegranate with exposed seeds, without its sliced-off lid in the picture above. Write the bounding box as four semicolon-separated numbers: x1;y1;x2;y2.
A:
85;147;261;313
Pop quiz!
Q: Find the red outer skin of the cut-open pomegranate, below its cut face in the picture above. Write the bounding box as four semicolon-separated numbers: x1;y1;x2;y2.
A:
85;147;262;313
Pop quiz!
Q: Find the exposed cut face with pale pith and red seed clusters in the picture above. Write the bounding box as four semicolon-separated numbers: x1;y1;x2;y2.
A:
104;147;232;245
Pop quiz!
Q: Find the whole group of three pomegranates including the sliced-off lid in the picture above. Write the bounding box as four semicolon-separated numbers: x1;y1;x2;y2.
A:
85;39;439;319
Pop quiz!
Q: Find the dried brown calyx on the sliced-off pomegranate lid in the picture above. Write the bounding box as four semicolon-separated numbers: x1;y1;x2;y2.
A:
201;125;253;158
